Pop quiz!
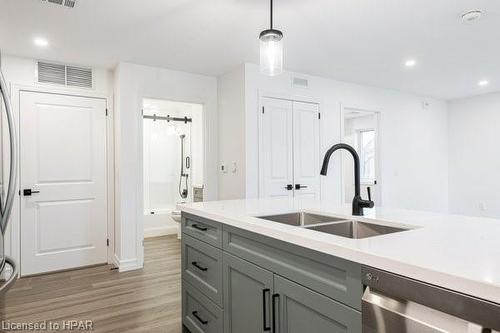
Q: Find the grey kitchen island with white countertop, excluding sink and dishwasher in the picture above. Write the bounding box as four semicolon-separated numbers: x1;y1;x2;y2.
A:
179;199;500;332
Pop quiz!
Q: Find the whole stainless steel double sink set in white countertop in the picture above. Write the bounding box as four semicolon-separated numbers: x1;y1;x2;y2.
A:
259;212;411;239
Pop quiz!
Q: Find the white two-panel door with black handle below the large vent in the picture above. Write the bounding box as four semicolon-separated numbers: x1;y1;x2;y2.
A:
20;92;107;275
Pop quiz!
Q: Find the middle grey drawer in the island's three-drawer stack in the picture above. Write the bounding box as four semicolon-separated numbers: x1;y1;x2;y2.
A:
182;235;222;306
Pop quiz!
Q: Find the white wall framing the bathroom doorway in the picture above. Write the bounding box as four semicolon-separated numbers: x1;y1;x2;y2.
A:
115;63;218;270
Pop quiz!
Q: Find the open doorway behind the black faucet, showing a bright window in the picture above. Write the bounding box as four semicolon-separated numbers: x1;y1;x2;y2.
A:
342;107;381;206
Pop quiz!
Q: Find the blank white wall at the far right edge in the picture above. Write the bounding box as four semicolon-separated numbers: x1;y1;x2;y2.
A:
449;93;500;218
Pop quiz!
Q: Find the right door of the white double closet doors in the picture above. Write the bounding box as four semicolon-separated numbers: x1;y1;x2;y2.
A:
293;102;320;198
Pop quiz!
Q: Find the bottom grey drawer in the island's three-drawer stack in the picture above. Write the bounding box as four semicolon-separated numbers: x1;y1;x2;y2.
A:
182;281;224;333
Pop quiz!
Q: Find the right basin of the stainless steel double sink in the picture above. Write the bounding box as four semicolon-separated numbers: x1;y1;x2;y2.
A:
306;221;410;239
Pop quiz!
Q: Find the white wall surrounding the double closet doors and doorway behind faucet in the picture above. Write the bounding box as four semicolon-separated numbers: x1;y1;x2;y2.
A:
245;64;448;212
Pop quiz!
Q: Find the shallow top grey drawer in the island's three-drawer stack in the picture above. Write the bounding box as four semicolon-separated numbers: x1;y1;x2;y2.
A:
182;213;222;248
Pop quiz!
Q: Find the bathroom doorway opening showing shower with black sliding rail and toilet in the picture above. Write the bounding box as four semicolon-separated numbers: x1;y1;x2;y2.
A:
143;98;204;237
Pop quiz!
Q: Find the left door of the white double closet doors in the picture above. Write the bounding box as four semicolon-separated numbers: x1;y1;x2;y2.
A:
259;98;293;197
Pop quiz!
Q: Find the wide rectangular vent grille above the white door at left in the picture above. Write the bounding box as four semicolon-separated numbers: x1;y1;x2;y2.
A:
37;61;93;88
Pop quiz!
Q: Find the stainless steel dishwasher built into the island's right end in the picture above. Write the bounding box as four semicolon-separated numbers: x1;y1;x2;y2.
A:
362;266;500;333
